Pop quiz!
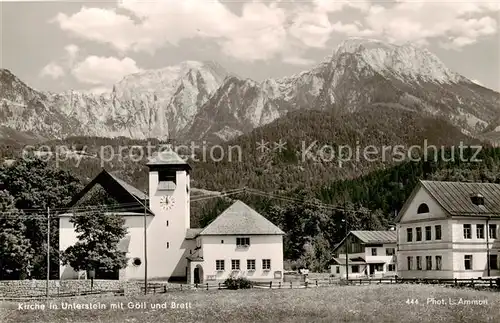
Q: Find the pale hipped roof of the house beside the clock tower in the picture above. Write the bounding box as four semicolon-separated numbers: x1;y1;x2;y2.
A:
200;201;284;235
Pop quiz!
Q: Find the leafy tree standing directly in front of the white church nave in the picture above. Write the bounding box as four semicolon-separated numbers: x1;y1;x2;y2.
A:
61;209;128;278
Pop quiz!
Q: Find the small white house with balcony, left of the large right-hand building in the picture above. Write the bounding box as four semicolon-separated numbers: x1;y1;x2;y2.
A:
330;231;397;278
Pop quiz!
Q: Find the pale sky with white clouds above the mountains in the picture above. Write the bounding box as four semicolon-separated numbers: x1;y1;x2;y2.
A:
0;0;500;93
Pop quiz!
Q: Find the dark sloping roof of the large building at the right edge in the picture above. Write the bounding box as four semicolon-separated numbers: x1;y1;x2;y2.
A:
420;181;500;216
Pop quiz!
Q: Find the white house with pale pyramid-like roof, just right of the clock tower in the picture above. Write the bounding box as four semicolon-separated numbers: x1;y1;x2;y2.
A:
188;201;284;283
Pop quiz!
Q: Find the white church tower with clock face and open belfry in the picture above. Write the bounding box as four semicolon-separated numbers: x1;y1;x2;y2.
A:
147;150;191;280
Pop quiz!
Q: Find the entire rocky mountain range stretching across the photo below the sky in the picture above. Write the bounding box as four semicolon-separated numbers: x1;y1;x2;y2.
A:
0;38;500;146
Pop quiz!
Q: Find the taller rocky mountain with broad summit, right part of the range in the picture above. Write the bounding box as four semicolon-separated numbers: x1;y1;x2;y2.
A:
191;38;500;140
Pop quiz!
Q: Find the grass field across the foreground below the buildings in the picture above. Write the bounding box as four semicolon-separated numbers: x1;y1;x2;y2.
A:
0;285;500;323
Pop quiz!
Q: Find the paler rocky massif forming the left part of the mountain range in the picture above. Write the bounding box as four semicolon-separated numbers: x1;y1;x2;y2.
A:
0;61;228;138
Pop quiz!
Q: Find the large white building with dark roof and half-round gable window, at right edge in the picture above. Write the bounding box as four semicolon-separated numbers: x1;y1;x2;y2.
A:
396;181;500;278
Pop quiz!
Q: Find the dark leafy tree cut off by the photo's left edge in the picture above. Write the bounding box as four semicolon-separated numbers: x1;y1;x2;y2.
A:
0;190;33;279
